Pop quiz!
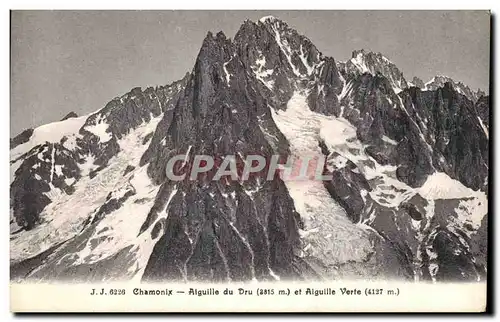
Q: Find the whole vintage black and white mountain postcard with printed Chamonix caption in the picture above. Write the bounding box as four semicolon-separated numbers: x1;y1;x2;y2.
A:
9;10;493;312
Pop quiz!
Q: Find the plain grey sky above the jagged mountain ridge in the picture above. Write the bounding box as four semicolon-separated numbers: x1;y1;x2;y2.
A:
10;10;490;136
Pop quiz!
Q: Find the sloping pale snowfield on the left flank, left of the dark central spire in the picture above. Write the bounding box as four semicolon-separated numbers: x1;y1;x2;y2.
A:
10;115;162;262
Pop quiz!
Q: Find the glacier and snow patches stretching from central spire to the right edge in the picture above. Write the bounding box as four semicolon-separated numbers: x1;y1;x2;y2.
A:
272;90;488;272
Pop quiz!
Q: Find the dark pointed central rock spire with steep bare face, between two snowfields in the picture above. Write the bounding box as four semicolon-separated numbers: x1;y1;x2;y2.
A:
141;33;300;281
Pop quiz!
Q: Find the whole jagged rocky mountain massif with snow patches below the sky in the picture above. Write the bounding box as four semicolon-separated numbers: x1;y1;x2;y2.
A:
10;17;489;282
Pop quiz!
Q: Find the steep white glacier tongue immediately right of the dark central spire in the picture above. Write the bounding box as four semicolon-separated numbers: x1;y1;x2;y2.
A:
272;91;372;265
